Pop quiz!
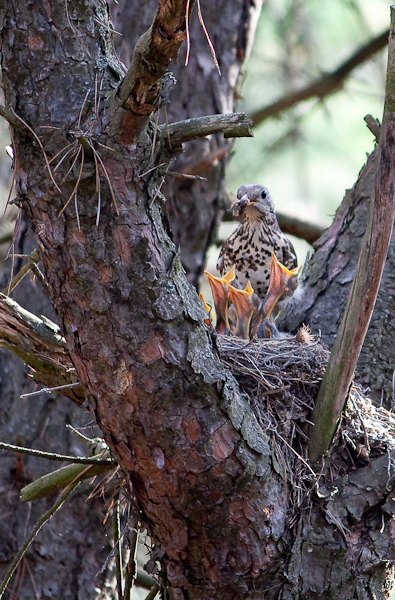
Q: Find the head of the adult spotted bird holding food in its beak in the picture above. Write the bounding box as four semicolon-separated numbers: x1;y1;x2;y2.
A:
230;184;276;225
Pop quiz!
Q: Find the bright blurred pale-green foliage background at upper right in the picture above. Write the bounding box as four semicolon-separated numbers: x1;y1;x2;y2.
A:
228;0;390;225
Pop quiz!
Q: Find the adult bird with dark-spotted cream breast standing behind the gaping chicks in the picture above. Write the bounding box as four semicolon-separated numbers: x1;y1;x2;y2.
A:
217;184;297;299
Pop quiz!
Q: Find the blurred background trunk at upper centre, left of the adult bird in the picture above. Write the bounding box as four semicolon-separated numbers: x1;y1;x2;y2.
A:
112;0;262;287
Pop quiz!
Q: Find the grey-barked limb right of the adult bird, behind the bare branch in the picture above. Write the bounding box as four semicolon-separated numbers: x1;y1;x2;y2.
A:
283;148;395;406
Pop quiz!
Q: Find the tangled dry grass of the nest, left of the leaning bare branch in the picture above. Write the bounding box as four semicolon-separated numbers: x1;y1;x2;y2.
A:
218;335;330;443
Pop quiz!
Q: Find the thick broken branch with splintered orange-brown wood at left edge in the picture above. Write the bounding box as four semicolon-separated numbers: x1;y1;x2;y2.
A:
0;294;89;405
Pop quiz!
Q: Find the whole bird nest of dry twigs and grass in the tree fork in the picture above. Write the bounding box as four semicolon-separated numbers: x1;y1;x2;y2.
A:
218;328;395;494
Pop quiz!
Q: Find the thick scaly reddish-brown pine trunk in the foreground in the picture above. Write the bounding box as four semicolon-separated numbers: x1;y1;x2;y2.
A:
2;0;394;600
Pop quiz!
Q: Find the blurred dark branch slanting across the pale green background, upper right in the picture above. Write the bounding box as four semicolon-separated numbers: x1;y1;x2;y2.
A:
249;30;389;127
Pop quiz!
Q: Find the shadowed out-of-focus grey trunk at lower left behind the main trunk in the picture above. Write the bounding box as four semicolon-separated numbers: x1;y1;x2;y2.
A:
0;221;112;600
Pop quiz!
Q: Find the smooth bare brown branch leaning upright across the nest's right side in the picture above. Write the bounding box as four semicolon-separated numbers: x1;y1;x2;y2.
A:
309;12;395;463
